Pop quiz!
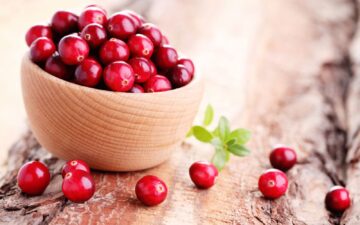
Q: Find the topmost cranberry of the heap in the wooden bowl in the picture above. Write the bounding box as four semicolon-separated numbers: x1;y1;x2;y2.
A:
79;7;107;30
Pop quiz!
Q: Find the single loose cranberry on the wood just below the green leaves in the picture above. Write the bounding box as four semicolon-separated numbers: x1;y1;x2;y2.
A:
189;161;219;189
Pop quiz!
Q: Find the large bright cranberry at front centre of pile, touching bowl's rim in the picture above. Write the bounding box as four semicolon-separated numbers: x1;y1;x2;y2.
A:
104;61;135;92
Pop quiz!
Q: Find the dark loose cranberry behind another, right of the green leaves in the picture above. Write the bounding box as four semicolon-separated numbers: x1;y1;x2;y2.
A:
270;147;296;172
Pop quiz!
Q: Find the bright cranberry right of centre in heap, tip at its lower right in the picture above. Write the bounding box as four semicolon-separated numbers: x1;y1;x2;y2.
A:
128;34;154;59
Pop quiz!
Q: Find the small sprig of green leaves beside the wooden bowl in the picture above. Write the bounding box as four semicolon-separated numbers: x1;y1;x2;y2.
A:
186;105;251;171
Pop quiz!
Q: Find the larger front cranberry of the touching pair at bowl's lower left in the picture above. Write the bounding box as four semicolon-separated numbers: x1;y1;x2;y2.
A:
62;170;95;203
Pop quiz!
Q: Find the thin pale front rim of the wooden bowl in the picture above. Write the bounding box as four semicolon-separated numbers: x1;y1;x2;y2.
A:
23;54;202;97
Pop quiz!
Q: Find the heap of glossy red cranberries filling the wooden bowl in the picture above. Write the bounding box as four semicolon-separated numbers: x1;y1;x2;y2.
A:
26;5;195;93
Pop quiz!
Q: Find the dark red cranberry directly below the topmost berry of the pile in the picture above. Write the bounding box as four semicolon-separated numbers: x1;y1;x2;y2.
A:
81;23;107;48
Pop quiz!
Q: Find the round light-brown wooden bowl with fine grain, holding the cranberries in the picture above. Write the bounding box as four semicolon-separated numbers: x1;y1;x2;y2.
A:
21;55;203;171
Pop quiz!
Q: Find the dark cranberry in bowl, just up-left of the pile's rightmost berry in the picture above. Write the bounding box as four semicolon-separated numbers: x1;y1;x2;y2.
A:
155;45;178;69
